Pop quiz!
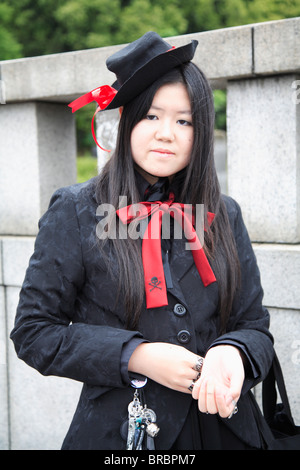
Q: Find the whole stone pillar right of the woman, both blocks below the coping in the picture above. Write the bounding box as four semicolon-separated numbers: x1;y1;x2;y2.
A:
227;74;300;423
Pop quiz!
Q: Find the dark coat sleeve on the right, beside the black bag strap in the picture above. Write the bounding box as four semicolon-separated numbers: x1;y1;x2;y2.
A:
211;198;274;388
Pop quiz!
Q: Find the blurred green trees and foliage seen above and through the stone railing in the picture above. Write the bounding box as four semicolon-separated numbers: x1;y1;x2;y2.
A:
0;0;300;182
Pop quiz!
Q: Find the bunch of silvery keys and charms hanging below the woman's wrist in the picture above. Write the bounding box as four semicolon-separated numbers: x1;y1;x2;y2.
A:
126;389;159;450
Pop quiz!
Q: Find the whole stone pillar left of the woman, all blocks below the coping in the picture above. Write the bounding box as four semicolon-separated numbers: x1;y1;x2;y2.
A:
0;102;81;450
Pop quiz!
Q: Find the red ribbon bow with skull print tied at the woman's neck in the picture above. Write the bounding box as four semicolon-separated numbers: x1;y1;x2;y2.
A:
117;193;216;308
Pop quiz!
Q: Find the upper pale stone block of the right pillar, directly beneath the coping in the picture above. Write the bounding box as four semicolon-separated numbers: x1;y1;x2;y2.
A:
227;75;300;243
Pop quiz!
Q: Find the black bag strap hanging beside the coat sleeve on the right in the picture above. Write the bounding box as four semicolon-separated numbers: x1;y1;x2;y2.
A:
262;352;294;425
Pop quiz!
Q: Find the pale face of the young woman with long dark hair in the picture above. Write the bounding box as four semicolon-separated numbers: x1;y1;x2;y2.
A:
131;83;194;184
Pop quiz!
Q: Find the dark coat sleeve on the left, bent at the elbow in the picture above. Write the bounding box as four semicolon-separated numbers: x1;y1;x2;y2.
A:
11;189;141;387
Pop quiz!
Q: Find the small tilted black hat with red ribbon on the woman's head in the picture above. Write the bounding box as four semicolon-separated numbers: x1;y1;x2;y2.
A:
69;31;198;148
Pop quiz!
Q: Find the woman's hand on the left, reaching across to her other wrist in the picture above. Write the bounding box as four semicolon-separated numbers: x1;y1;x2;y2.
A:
128;343;199;394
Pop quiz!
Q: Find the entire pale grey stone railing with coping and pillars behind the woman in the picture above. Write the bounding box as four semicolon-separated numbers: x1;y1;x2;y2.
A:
0;18;300;449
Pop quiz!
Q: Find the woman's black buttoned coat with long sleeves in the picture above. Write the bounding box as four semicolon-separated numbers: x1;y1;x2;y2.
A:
11;180;273;450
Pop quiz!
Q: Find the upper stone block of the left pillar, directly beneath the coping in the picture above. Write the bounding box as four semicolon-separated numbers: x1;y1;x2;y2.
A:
0;102;76;235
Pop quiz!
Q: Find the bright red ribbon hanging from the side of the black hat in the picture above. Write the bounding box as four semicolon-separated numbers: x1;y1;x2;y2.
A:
68;85;118;152
